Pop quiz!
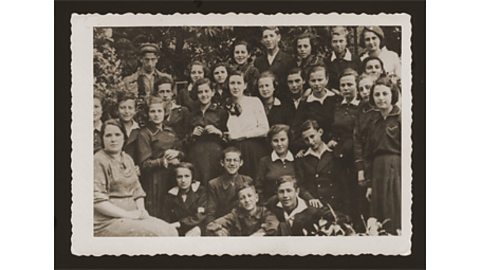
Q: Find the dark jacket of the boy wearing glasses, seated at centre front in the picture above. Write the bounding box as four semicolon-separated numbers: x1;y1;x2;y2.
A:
205;174;253;224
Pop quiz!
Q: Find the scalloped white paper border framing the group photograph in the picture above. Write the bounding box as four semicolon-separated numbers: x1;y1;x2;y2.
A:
71;13;412;256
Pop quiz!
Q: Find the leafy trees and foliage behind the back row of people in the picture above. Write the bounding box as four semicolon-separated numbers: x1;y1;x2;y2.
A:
93;26;401;117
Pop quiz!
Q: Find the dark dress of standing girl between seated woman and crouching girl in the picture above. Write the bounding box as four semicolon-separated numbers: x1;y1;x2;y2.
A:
138;122;182;217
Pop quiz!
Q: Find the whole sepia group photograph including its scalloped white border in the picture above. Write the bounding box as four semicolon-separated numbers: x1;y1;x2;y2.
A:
71;13;414;255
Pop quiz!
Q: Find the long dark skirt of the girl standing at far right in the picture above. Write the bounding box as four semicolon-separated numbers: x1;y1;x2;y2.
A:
371;155;402;234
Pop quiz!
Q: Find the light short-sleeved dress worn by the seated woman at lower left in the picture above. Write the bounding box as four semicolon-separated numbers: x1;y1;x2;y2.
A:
93;149;178;236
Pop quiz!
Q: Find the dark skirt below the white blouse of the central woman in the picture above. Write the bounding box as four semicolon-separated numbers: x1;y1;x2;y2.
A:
233;138;268;179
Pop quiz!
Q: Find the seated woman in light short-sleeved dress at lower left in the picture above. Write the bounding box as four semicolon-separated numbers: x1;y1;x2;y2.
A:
93;120;178;236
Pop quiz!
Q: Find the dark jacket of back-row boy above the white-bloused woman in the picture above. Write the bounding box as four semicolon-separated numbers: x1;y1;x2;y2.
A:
254;50;296;100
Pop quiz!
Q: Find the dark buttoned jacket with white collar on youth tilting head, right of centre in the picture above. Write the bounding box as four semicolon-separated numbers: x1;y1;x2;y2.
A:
297;144;345;211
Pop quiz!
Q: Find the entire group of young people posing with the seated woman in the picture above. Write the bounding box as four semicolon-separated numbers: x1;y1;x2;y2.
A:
94;26;401;236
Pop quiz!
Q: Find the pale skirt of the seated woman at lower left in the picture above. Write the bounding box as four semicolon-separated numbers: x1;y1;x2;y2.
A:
94;197;178;236
